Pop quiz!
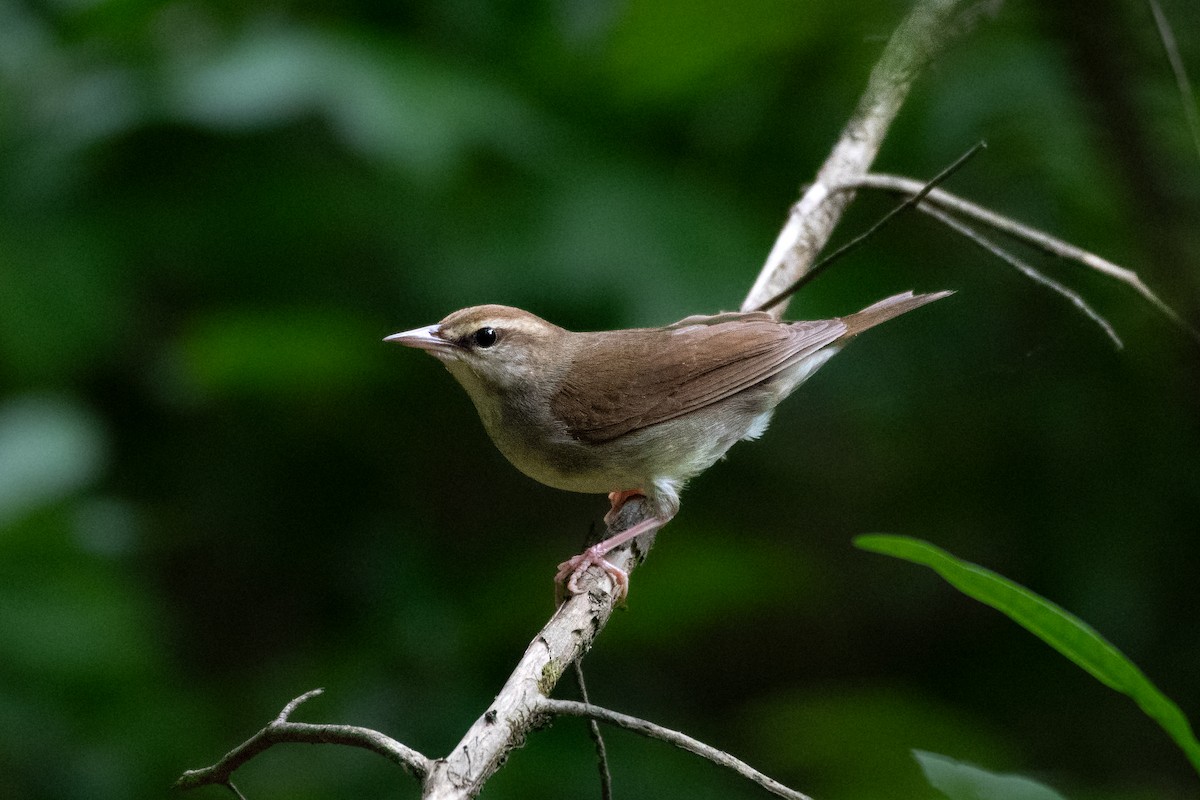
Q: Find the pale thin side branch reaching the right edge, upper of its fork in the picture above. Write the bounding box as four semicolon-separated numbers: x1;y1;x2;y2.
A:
834;174;1200;342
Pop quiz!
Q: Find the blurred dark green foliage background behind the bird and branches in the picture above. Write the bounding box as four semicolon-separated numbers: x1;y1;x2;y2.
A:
0;0;1200;800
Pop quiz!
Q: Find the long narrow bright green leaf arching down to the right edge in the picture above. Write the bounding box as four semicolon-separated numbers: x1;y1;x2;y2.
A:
854;534;1200;775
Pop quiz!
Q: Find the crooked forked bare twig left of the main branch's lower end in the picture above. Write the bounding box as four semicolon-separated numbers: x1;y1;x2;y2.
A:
175;688;432;798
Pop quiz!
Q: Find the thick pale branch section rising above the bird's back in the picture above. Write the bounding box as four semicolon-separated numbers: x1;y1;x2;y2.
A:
742;0;996;319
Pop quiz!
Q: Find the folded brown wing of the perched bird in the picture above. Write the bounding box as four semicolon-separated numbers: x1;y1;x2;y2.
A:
551;314;846;443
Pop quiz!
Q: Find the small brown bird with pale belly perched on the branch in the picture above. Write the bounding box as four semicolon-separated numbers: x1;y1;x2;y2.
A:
384;291;953;601
